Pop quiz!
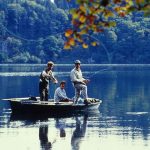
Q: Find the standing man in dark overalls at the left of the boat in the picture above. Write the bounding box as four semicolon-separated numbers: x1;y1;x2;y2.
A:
39;61;58;101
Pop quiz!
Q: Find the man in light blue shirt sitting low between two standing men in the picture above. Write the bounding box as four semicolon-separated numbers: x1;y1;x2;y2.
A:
54;81;71;103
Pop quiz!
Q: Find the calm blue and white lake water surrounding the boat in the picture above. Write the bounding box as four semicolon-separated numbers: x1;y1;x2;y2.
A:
0;65;150;150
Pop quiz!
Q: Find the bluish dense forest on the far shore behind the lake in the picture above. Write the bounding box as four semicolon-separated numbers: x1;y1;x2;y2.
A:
0;0;150;64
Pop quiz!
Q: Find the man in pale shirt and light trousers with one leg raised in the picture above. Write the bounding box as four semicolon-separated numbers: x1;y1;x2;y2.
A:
70;60;89;103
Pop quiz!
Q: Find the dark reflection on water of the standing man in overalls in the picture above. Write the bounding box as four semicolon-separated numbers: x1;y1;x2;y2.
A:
39;125;52;150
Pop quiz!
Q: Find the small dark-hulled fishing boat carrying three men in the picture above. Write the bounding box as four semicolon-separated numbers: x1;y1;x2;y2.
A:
3;97;102;115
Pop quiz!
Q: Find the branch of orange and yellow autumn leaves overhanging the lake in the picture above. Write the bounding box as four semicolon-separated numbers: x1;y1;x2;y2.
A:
64;0;150;49
